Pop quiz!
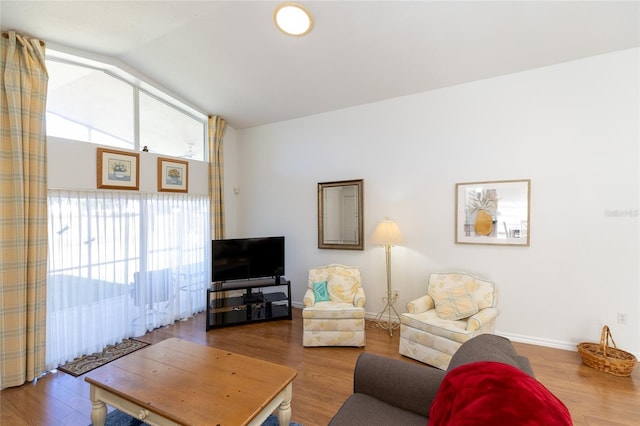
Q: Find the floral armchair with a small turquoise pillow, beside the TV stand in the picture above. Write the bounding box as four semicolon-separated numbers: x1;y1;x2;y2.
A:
302;264;366;347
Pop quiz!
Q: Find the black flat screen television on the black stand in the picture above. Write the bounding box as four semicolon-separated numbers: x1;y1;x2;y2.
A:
211;237;284;282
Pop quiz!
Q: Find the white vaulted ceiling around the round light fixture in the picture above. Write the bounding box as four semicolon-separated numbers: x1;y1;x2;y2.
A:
0;0;640;129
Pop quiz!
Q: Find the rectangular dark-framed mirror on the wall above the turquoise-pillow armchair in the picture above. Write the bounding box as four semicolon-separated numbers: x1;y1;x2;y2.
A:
318;179;364;250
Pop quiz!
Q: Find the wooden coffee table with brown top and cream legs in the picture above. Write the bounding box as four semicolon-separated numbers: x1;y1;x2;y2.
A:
85;338;297;426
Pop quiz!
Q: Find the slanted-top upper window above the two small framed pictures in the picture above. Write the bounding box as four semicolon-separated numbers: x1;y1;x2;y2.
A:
47;55;207;161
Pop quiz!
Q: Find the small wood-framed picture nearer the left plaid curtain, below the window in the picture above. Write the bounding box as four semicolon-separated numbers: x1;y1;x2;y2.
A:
97;148;140;190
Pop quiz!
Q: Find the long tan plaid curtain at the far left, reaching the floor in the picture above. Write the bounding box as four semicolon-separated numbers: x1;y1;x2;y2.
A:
0;31;49;389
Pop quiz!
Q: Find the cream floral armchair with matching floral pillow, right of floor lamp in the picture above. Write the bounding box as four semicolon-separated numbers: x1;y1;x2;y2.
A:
400;273;498;370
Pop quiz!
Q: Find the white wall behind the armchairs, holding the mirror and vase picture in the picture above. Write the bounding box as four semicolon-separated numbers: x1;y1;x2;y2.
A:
231;49;640;353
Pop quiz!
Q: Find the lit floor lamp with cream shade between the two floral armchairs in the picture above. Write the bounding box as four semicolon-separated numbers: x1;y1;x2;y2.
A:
371;217;404;336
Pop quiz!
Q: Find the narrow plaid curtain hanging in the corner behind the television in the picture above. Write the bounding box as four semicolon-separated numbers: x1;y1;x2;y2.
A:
208;116;227;239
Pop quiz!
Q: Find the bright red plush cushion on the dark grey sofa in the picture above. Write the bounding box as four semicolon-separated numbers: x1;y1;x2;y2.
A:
429;361;573;426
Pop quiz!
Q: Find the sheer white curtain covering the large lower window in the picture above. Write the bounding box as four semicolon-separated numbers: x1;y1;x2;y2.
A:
47;190;211;369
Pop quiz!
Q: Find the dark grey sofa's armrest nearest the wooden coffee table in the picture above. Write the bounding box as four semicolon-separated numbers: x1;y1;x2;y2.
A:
353;352;446;417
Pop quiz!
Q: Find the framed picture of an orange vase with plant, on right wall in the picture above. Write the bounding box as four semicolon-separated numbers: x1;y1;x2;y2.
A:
456;179;531;246
